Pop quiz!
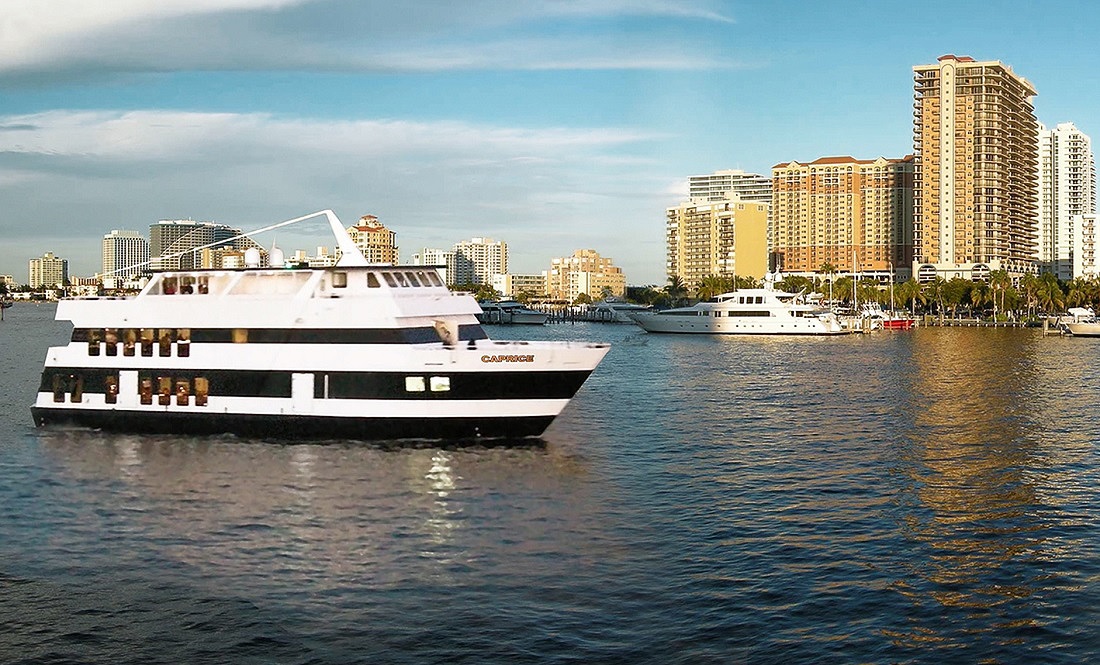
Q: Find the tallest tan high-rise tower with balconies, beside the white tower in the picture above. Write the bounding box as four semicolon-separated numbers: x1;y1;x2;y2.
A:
913;55;1038;281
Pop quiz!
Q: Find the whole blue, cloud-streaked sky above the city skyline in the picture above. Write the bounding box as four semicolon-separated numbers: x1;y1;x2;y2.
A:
0;0;1100;285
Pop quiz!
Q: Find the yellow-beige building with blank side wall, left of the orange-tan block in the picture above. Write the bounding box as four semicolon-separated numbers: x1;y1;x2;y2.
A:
664;197;771;288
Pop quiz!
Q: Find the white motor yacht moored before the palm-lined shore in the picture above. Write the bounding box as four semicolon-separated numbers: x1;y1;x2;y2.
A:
629;274;853;335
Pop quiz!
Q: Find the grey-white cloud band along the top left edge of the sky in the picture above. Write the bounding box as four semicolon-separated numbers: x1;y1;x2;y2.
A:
0;0;730;80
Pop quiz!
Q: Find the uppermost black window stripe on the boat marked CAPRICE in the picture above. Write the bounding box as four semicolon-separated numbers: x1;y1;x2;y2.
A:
72;324;488;345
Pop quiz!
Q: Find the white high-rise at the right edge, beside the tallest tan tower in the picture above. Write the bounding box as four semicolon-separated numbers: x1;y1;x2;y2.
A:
1036;122;1097;280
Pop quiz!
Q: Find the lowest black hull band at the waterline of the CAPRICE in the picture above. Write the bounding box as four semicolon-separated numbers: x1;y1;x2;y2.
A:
31;407;553;441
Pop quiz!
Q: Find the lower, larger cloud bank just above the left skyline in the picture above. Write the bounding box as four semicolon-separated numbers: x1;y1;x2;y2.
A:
0;111;670;280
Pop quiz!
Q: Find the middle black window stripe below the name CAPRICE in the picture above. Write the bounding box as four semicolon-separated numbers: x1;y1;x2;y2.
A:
39;367;591;400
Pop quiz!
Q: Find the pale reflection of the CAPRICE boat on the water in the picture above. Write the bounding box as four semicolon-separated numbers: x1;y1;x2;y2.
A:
39;430;598;595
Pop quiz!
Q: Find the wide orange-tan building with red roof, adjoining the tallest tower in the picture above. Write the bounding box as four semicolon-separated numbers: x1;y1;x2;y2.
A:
771;155;914;277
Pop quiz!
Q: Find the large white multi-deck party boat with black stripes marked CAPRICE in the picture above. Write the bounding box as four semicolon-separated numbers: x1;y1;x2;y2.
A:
31;210;608;440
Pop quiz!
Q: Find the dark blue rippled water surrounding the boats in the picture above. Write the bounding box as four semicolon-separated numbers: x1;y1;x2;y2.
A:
0;306;1100;664
